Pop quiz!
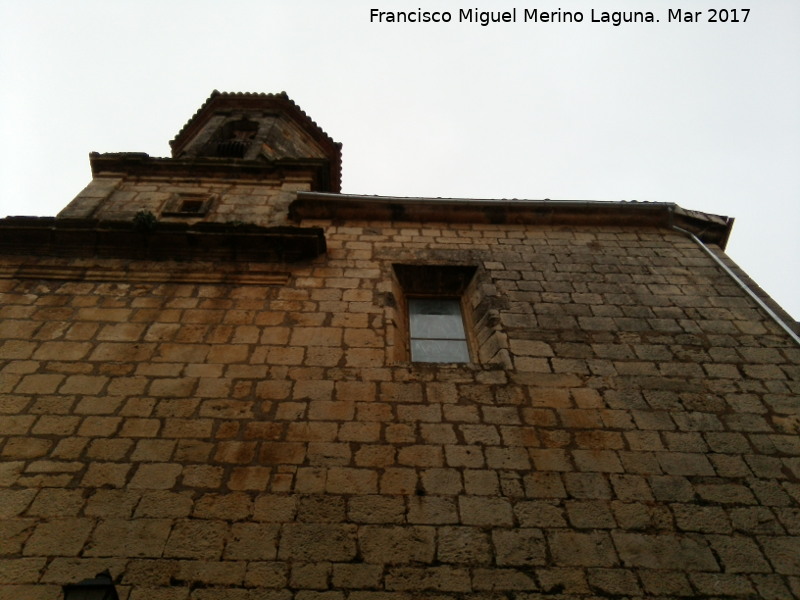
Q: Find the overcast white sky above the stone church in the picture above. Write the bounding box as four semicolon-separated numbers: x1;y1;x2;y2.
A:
0;0;800;318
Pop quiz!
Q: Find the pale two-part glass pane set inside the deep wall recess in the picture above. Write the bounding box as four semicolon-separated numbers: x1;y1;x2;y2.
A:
408;298;469;363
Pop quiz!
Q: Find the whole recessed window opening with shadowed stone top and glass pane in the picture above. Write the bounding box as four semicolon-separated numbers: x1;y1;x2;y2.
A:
394;264;476;363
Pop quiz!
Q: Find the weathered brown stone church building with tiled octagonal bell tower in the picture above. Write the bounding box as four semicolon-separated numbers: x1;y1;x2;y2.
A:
0;92;800;600
